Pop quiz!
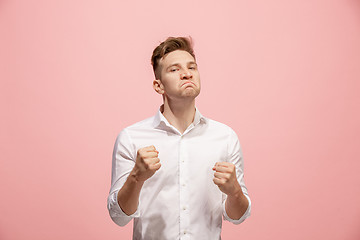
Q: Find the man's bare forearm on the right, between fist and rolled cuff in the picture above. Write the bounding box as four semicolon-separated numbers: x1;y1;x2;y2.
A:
225;188;249;220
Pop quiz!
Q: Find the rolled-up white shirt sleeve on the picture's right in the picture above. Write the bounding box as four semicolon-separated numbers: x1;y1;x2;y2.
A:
222;129;251;224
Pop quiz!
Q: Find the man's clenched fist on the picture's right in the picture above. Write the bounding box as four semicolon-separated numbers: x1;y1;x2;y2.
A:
213;162;242;197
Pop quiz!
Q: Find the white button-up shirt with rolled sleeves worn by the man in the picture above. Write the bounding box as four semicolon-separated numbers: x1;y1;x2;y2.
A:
108;110;251;240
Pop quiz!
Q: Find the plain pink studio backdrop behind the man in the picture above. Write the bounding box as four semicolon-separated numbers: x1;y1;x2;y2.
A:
0;0;360;240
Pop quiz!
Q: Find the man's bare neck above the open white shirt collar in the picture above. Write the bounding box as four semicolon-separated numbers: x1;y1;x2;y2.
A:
163;98;195;134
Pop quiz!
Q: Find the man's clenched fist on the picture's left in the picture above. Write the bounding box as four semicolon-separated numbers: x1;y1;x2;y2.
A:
133;145;161;182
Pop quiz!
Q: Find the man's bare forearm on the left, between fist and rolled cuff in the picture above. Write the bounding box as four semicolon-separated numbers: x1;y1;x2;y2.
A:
117;171;144;215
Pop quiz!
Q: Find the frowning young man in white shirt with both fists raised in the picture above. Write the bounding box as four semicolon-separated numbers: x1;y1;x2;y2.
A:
108;37;251;240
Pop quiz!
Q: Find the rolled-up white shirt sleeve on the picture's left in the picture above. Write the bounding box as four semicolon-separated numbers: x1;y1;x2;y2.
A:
107;129;140;226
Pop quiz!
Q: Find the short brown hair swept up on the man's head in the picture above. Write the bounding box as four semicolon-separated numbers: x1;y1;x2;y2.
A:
151;37;195;77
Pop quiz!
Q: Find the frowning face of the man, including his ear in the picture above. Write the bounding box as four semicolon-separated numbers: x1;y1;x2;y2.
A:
153;50;200;100
